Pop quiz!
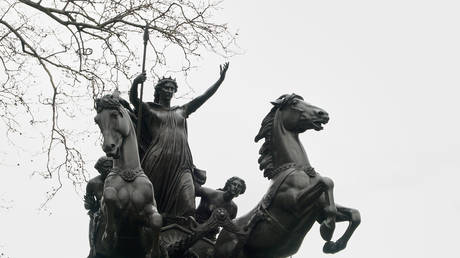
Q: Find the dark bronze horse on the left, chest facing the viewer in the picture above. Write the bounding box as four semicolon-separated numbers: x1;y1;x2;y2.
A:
94;93;162;258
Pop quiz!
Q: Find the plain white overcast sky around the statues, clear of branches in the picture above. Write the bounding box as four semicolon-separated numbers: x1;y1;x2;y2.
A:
0;0;460;258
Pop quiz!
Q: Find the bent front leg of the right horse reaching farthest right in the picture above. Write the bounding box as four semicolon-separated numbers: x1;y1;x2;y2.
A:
323;204;361;253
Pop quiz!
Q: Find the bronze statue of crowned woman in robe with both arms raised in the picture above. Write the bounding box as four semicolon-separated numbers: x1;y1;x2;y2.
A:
130;63;228;217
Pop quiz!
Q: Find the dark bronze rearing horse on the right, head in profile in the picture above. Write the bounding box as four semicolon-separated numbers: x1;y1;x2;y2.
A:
215;94;361;258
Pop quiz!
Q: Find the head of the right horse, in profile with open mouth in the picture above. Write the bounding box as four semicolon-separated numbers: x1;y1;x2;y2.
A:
272;94;329;133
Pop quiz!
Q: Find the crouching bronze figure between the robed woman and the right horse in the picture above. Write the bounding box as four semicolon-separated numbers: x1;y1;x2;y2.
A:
195;176;246;240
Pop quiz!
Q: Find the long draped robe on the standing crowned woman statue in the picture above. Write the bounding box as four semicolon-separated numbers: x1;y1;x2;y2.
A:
140;103;195;217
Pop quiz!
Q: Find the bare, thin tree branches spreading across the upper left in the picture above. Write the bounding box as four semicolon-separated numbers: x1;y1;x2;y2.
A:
0;0;236;204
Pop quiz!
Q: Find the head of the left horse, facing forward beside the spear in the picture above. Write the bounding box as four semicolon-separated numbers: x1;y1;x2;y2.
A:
94;91;134;159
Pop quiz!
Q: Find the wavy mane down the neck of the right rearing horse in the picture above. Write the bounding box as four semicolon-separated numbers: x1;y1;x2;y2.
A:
254;93;303;179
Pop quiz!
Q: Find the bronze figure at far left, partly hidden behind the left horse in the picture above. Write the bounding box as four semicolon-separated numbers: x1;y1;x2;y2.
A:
84;156;113;258
